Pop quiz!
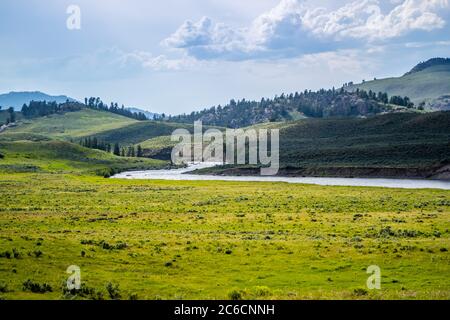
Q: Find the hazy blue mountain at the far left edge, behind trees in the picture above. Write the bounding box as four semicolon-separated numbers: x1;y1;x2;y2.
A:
0;91;76;111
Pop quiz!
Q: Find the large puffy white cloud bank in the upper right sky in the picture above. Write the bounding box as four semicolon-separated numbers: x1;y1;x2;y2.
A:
163;0;448;60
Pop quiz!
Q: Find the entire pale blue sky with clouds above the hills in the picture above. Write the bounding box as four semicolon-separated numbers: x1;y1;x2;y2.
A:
0;0;450;114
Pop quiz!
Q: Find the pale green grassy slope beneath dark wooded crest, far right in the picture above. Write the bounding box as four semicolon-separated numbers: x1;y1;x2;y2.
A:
350;65;450;104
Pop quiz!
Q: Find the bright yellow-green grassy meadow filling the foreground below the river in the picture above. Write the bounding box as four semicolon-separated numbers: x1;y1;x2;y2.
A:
0;173;450;299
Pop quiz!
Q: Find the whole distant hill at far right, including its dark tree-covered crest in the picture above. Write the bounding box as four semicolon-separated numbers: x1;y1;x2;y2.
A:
346;58;450;110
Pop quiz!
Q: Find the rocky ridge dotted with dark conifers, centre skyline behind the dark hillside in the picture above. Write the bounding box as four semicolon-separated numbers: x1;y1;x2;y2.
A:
165;88;402;128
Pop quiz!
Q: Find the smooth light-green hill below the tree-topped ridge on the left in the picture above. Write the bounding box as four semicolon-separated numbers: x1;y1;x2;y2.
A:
8;109;137;139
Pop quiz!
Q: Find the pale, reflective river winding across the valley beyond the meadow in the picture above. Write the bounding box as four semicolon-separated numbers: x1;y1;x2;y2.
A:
112;163;450;190
